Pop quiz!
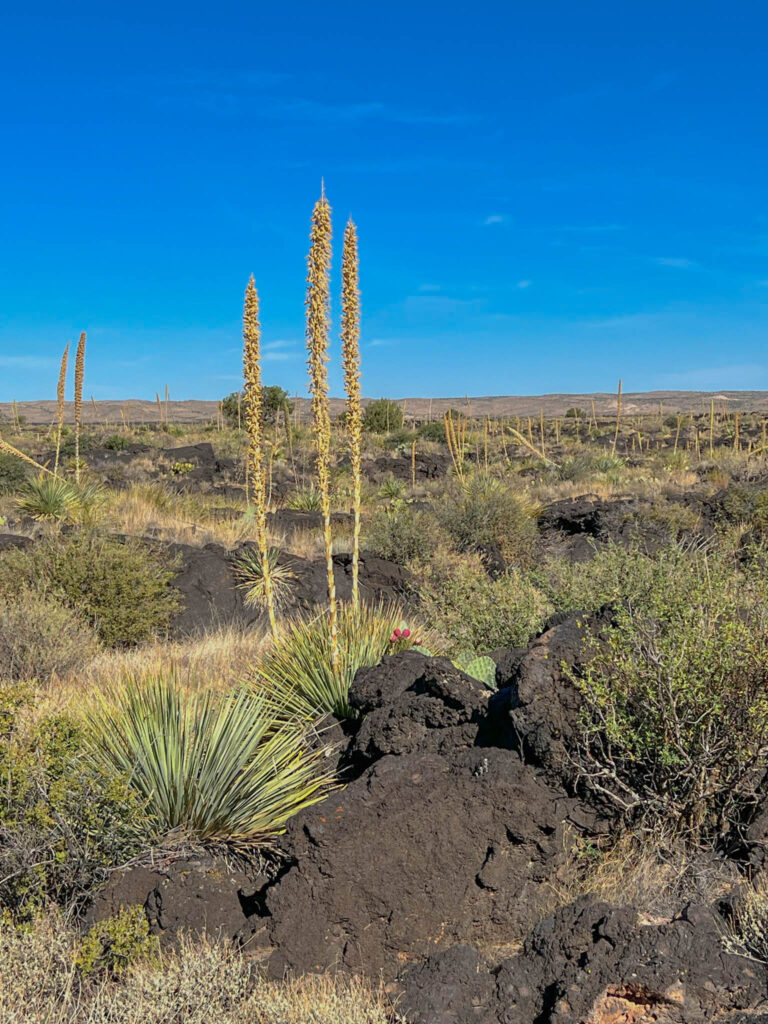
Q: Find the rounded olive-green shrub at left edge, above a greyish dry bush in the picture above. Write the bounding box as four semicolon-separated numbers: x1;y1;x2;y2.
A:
0;530;178;646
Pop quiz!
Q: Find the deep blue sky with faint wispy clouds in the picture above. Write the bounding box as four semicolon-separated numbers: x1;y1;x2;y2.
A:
0;0;768;400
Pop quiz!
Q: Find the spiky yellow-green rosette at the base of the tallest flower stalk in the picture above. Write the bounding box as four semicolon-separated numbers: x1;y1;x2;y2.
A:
254;603;402;719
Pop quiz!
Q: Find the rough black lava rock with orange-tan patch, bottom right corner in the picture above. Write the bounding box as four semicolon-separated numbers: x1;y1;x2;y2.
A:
398;897;768;1024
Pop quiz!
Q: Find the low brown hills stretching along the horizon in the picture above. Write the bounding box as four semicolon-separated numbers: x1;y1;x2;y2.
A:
0;391;768;427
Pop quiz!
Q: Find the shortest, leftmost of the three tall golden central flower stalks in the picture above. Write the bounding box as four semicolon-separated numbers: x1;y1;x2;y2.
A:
243;274;278;639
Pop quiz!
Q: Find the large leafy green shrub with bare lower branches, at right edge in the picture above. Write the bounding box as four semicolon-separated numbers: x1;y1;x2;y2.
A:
574;547;768;839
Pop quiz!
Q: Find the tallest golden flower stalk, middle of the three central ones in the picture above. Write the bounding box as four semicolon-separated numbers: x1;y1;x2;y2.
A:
304;188;339;666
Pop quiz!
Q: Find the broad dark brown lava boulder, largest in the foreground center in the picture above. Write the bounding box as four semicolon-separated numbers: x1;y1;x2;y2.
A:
266;748;584;978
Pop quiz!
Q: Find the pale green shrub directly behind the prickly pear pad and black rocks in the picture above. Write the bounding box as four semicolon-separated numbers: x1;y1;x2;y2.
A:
417;552;551;655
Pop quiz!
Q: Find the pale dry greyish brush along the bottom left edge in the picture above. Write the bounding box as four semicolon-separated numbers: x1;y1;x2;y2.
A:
0;914;393;1024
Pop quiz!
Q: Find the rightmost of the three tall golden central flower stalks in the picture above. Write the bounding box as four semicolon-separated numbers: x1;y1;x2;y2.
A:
341;217;362;606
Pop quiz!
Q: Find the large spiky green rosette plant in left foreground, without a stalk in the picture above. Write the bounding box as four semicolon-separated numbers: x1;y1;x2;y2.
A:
87;676;333;846
